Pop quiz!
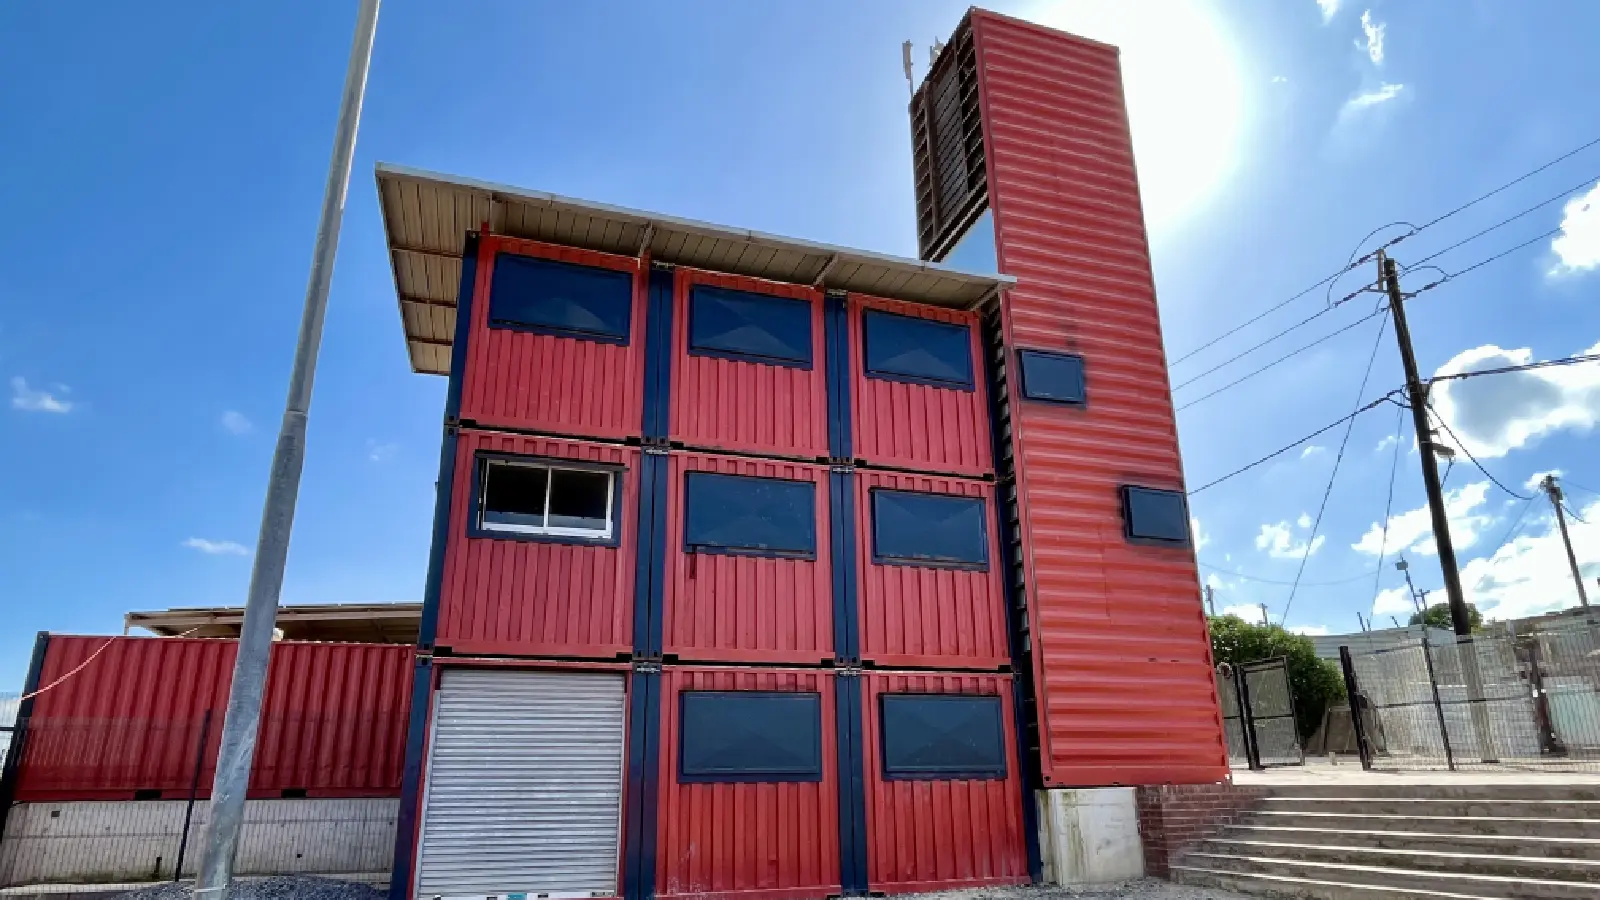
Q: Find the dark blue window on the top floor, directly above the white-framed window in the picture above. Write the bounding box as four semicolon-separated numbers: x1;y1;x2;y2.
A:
490;253;634;344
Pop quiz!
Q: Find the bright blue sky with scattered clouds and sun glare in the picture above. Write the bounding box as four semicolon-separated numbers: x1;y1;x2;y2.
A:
0;0;1600;687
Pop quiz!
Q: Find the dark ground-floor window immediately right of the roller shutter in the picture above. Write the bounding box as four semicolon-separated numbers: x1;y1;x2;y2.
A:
678;690;822;783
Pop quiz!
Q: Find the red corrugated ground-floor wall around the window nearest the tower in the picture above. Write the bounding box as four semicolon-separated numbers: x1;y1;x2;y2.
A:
862;673;1029;894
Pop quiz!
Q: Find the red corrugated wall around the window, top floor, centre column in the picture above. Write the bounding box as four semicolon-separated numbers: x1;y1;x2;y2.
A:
670;269;827;458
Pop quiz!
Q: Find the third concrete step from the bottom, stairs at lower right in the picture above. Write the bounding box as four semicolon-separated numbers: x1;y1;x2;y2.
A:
1219;820;1600;860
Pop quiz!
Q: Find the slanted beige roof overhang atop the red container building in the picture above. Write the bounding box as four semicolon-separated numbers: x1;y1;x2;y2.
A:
376;163;1014;375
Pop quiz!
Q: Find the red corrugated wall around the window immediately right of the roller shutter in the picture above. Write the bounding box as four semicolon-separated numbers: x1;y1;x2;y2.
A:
656;666;840;900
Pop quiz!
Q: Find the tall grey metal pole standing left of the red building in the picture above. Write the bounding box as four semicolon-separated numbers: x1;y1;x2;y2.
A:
195;0;379;900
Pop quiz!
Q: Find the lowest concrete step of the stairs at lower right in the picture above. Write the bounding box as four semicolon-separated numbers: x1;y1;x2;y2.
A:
1176;850;1600;900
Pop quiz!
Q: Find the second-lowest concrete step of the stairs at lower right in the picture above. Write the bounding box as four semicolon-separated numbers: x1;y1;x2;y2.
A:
1195;839;1600;884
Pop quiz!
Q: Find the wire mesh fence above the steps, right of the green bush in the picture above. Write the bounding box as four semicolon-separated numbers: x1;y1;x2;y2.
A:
1341;618;1600;770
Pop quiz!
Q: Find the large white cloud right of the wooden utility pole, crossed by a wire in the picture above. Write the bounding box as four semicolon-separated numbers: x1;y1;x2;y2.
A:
1432;344;1600;460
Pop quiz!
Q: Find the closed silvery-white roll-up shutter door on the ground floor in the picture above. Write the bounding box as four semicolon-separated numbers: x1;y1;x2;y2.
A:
416;669;626;900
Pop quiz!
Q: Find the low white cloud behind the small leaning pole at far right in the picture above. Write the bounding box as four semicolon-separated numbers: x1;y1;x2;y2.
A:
1461;490;1600;618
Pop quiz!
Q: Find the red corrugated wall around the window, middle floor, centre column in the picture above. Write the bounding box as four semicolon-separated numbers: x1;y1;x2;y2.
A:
662;450;834;663
